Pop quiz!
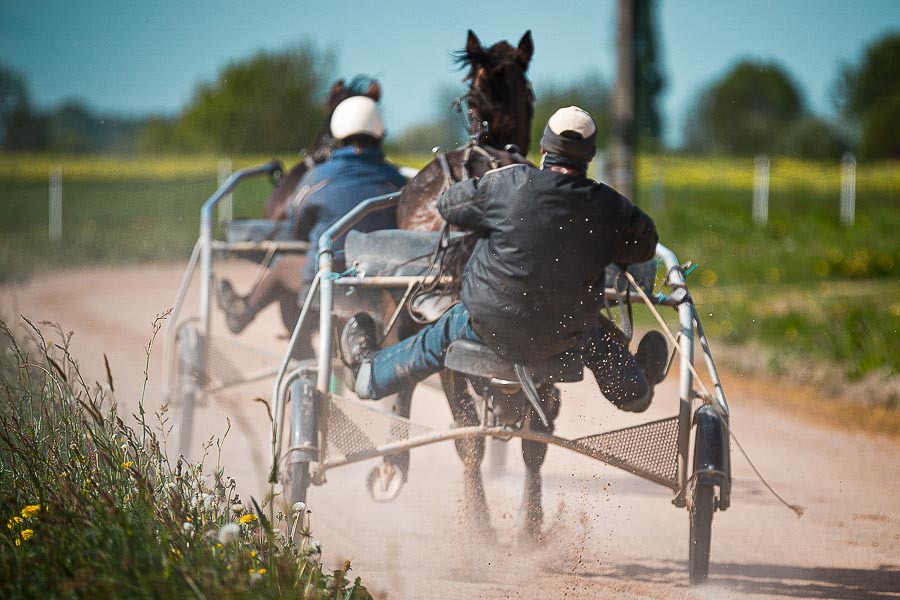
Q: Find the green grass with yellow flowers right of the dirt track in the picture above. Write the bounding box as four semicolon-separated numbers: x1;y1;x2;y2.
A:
624;178;900;390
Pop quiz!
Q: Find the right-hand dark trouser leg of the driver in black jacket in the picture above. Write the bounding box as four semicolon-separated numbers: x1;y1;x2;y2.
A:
582;315;656;412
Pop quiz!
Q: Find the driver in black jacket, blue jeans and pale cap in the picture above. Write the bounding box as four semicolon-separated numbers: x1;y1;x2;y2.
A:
341;106;668;412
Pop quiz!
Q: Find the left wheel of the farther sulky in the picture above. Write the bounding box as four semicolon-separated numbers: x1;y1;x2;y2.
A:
172;321;205;454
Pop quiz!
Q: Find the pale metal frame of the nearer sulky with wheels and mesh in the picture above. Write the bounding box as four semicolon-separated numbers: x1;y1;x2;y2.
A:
271;194;731;583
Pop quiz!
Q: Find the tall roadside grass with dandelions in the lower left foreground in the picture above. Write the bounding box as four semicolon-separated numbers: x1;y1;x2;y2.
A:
0;320;371;600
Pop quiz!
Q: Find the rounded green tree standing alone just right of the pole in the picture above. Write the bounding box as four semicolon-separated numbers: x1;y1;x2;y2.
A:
685;61;805;155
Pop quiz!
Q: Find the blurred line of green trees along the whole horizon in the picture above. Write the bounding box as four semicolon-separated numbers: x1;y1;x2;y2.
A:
0;32;900;159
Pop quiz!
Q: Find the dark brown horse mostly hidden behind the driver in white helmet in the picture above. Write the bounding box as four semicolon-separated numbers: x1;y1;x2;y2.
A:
265;75;381;221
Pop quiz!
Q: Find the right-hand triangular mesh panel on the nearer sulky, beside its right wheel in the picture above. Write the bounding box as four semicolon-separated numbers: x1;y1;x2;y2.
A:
573;417;678;489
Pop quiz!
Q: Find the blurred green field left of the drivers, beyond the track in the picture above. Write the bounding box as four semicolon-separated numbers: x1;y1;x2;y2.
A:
0;177;271;281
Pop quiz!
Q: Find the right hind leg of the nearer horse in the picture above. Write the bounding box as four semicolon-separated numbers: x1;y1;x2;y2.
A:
521;384;559;542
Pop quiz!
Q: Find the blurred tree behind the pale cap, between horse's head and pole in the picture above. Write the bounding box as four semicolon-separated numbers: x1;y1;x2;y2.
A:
531;73;610;156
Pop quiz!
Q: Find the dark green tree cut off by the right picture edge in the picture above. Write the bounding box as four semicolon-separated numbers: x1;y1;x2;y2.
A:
835;33;900;159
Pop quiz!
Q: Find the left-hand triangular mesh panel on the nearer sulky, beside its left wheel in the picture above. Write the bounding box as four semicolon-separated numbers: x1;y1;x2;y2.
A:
325;396;434;460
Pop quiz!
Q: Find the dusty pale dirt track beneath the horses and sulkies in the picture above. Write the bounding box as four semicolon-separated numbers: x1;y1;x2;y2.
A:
0;264;900;600
